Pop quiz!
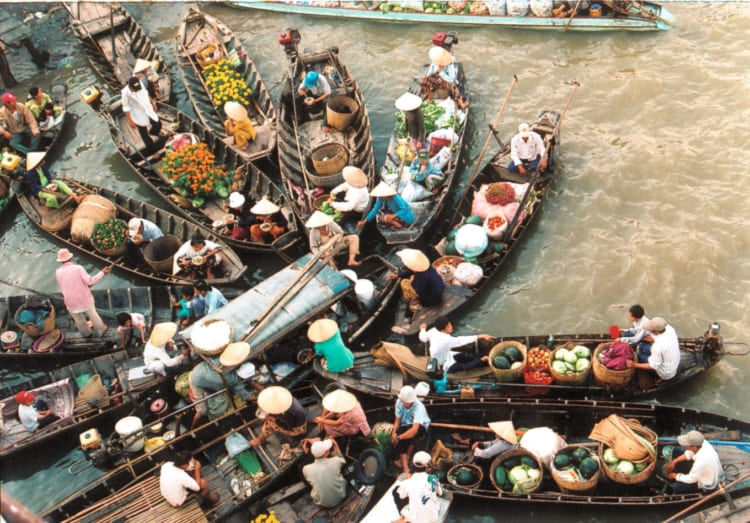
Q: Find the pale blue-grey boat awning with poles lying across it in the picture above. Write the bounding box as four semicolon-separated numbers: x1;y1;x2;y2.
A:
180;254;352;358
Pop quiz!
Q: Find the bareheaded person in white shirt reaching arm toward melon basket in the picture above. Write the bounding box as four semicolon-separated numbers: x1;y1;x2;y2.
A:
419;316;495;372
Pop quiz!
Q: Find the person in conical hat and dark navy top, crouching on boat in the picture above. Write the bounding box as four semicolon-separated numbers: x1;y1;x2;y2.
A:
389;249;445;311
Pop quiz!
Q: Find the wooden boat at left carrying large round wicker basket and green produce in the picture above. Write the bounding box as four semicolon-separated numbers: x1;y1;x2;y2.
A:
18;180;247;285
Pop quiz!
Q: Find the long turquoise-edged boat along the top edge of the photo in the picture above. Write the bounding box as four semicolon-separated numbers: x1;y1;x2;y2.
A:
230;0;674;32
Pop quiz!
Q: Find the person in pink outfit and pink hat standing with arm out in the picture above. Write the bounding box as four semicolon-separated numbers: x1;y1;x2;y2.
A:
55;249;112;338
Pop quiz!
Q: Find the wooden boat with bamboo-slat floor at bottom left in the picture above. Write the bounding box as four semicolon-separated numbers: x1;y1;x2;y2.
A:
42;387;322;522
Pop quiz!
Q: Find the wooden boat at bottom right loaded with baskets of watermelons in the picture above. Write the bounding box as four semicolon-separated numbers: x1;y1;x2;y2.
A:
367;398;750;509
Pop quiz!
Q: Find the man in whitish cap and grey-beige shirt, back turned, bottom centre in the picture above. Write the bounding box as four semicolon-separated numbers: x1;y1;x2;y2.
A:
302;439;346;507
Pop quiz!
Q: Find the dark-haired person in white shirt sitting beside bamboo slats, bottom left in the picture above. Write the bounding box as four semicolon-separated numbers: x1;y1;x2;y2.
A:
159;452;220;508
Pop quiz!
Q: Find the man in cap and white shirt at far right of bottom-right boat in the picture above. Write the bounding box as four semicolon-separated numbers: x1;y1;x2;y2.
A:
667;430;724;494
